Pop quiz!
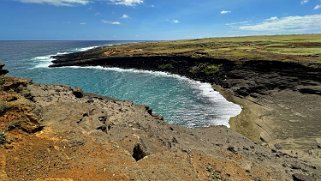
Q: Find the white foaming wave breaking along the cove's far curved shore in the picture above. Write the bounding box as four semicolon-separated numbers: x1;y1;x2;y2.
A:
61;66;242;127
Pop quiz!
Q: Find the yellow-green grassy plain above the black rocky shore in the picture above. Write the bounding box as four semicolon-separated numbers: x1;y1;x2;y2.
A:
100;34;321;68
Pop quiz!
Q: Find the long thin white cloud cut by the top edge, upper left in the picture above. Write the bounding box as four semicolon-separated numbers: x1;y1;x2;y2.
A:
20;0;90;6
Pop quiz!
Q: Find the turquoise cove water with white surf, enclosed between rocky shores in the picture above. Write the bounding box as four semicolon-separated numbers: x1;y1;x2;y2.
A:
29;66;241;127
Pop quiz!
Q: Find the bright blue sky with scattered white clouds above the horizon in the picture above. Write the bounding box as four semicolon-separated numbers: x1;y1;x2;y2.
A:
0;0;321;40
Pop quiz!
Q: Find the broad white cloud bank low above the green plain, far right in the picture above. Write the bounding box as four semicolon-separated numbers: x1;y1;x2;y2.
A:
239;14;321;33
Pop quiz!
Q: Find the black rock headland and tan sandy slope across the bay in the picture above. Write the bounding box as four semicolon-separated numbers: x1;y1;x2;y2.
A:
51;35;321;168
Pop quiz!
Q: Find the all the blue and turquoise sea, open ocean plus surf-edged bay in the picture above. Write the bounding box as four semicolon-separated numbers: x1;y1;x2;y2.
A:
0;41;241;127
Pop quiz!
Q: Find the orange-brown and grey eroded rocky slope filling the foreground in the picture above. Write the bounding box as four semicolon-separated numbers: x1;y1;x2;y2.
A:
0;63;321;180
